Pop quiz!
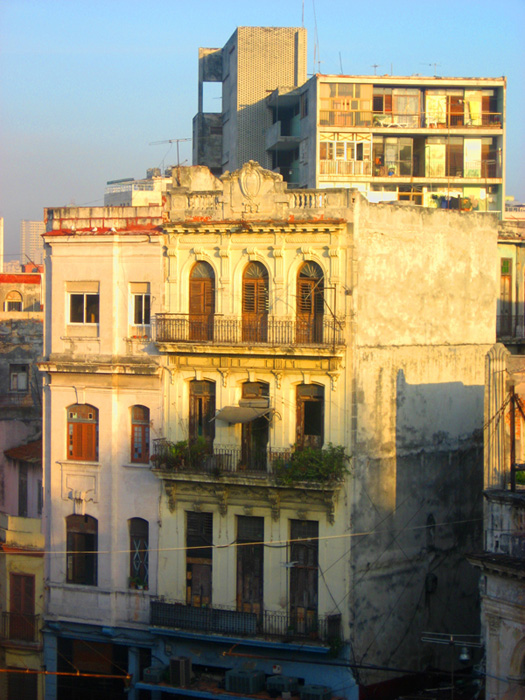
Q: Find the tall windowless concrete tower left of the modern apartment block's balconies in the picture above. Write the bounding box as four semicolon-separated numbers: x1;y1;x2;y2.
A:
193;27;306;175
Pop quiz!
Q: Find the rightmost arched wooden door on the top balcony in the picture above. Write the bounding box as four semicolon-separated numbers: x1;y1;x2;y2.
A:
296;262;324;344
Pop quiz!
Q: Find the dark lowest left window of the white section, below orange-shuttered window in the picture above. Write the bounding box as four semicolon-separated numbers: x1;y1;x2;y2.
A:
66;515;98;586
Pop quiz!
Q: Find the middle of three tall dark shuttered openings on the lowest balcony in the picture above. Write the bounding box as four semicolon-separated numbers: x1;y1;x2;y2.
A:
237;515;264;613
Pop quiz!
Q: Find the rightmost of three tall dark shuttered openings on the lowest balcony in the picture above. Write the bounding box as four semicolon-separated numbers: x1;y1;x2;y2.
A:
289;520;319;634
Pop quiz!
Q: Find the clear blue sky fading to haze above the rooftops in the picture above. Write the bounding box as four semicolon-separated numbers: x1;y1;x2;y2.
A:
0;0;525;261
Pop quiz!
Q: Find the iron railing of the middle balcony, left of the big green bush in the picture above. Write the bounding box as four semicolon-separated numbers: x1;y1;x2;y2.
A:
151;438;293;475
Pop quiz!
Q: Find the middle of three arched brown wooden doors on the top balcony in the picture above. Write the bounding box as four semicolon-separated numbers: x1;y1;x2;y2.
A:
242;262;268;343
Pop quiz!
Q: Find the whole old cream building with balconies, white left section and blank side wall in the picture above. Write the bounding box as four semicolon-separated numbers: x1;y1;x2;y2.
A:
41;162;497;700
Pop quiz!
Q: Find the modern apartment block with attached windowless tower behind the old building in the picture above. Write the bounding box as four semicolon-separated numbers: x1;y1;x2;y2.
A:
193;27;506;215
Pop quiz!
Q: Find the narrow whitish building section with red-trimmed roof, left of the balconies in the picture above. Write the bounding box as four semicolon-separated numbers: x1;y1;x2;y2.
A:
40;206;162;699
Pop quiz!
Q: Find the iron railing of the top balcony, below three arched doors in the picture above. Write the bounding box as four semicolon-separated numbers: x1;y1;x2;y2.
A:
155;313;345;347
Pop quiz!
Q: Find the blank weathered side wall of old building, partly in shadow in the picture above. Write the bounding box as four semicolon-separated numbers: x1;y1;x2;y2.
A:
351;199;496;681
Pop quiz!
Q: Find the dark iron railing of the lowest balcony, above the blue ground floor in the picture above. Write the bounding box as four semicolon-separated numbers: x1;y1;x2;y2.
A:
150;599;342;644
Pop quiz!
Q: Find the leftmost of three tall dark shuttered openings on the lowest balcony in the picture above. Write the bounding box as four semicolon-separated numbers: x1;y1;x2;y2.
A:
186;511;213;608
